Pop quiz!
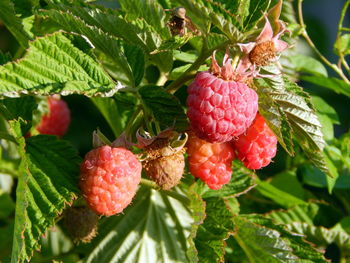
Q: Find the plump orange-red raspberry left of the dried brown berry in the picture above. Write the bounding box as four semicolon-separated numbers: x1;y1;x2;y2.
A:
80;146;142;216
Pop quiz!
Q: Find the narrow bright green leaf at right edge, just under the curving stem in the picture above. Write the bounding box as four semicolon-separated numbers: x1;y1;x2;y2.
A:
301;76;350;98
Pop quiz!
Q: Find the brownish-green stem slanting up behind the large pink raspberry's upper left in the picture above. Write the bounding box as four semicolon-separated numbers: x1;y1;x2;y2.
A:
166;38;229;93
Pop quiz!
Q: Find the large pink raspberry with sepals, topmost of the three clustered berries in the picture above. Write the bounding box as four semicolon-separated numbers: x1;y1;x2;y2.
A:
187;58;258;143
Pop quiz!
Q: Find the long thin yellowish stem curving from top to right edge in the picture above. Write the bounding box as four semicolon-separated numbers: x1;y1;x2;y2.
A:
298;0;350;84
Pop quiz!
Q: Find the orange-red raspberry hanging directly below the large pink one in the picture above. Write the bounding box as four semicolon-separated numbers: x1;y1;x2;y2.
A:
187;134;234;190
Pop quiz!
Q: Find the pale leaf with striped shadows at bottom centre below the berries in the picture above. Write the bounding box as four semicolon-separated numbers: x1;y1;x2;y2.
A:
83;187;191;263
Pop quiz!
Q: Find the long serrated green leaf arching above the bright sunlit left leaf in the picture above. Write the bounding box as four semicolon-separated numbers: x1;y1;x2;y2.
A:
42;5;172;72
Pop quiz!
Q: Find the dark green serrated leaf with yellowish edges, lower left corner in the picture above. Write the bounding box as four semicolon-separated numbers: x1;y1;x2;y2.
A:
12;135;81;262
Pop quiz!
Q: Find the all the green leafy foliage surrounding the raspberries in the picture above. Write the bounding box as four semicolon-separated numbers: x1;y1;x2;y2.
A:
0;0;350;263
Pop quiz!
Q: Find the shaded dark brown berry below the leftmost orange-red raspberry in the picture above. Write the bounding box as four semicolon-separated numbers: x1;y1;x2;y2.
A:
63;207;99;243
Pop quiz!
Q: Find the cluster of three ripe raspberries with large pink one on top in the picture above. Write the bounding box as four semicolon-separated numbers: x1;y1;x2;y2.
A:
187;51;277;189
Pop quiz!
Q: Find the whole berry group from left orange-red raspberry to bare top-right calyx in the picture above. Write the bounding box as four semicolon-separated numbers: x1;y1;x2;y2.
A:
75;11;288;221
